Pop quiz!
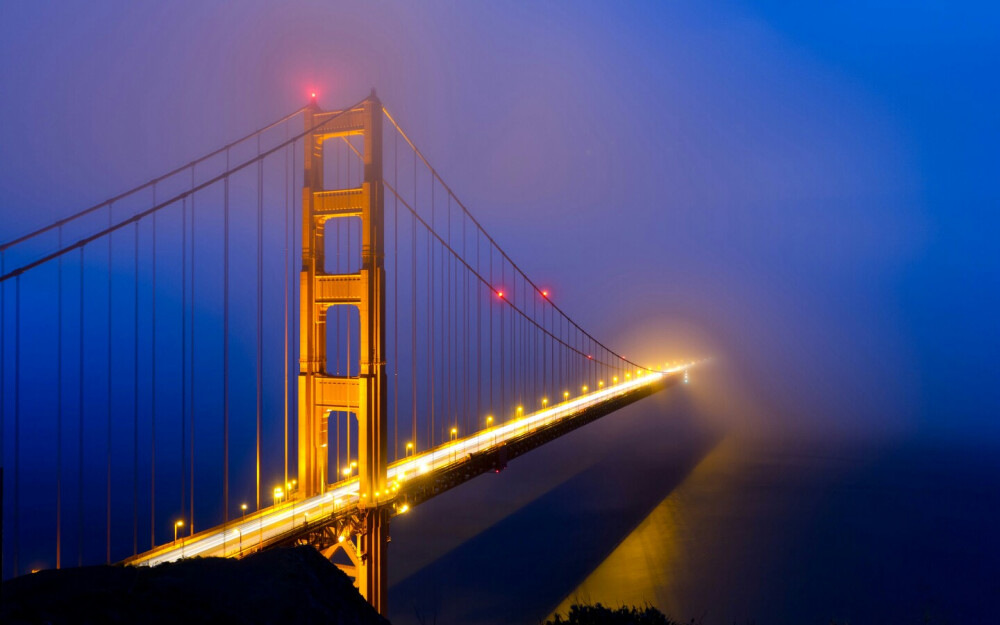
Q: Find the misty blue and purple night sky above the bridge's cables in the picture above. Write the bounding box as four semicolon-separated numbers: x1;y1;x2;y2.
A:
0;1;1000;444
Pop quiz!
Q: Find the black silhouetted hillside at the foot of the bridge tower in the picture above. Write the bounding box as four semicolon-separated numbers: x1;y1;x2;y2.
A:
0;547;388;625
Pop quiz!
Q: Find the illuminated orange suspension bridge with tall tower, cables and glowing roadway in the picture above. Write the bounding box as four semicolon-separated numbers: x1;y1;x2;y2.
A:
0;91;694;613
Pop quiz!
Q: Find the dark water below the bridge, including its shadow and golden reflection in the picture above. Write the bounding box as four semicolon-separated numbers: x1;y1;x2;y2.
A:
390;371;1000;625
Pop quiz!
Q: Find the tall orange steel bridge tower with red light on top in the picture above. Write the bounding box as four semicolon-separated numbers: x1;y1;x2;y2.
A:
298;90;390;614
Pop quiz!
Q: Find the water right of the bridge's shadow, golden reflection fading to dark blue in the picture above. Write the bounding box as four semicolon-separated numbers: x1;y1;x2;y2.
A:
554;439;1000;625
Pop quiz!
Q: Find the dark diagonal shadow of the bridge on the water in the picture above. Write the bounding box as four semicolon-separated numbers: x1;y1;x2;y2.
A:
389;390;721;624
